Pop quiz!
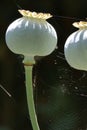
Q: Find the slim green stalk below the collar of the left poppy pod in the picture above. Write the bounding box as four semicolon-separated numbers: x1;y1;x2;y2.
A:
25;65;40;130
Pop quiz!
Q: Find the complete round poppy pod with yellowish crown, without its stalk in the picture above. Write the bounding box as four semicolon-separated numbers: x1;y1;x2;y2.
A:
6;10;57;64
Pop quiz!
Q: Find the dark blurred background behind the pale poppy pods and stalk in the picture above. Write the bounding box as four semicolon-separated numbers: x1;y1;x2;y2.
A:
0;0;87;130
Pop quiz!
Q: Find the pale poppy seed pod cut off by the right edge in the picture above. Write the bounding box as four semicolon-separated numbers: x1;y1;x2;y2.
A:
64;21;87;70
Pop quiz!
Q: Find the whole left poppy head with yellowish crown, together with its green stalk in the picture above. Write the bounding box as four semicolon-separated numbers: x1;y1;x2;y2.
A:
6;10;57;130
